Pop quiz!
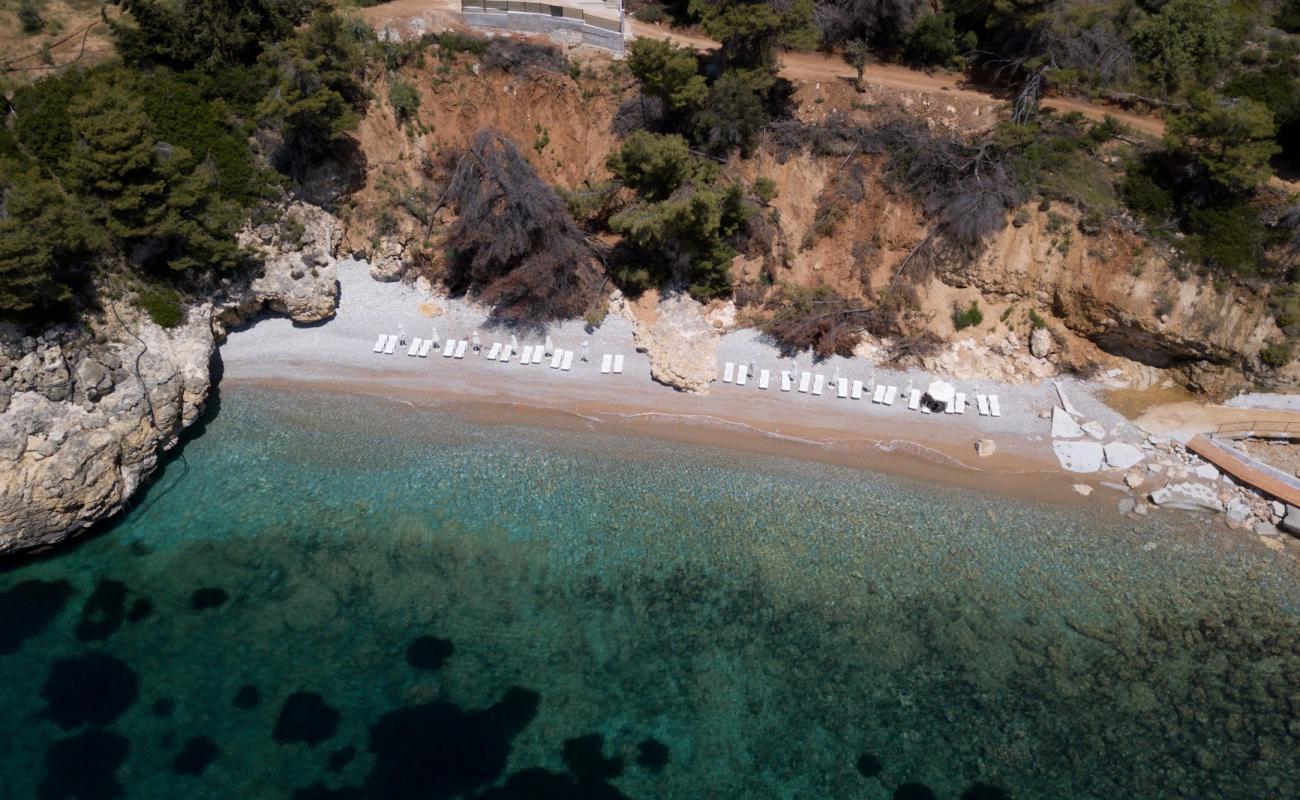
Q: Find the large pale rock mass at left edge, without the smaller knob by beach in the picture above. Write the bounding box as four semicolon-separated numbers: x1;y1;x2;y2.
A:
0;304;213;553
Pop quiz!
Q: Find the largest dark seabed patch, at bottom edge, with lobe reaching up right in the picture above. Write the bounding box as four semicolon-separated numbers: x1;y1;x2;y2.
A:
365;687;540;800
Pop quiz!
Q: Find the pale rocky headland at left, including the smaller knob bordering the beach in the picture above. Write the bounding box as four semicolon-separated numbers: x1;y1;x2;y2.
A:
0;206;338;554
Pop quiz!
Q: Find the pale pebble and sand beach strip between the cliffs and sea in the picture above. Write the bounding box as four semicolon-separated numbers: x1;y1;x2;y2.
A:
221;261;1136;502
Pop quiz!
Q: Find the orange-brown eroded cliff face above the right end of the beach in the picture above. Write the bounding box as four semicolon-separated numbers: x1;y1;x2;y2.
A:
940;208;1281;394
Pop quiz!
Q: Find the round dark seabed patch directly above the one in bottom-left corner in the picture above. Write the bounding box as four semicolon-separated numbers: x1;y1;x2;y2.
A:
40;653;140;730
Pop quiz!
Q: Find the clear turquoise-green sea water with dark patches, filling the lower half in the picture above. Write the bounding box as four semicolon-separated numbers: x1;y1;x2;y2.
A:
0;389;1300;800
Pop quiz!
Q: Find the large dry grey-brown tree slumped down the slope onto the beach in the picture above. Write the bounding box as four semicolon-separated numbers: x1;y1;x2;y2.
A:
446;129;602;324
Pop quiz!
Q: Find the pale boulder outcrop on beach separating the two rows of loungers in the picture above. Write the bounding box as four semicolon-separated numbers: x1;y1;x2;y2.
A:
612;294;722;393
